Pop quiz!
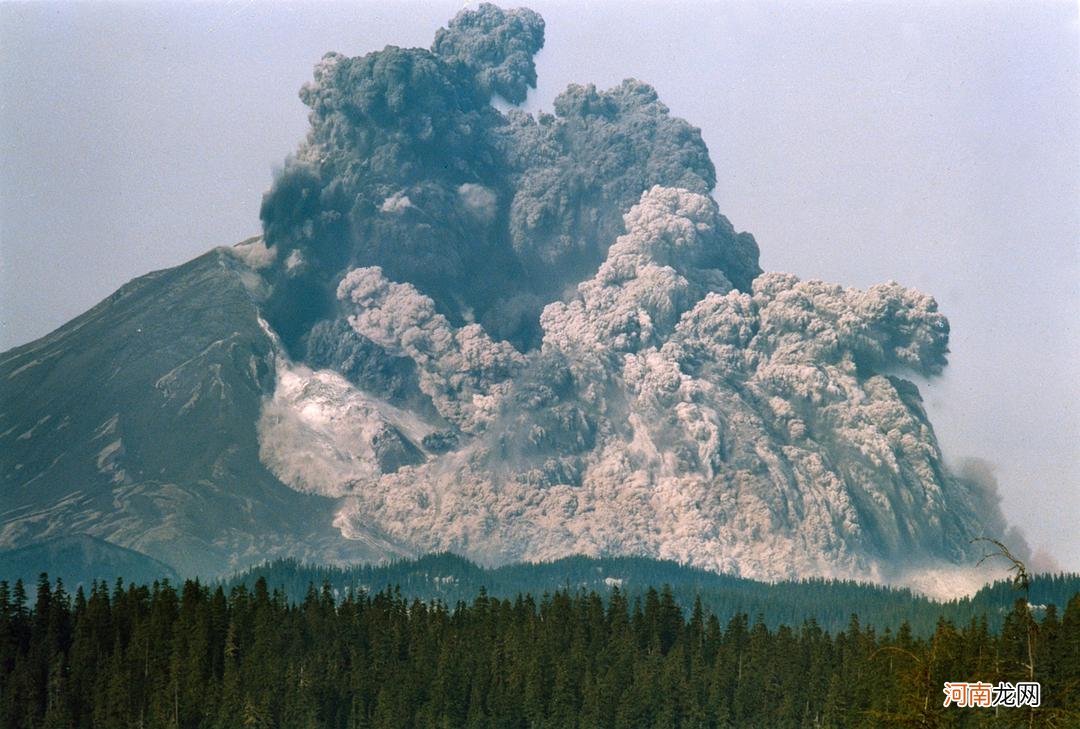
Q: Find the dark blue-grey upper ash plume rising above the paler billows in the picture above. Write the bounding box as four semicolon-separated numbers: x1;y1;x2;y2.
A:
261;4;743;356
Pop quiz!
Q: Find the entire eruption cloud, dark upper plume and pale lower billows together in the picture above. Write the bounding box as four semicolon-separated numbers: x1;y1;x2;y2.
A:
248;4;1001;578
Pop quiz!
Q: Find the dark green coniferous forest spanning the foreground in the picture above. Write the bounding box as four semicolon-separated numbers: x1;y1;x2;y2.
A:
0;576;1080;729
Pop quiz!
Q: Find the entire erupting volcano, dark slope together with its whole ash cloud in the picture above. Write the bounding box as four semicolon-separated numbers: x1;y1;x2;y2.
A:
0;4;1004;579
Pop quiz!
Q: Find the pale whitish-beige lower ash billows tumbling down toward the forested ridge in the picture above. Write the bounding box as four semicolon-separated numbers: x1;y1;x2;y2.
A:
261;188;981;578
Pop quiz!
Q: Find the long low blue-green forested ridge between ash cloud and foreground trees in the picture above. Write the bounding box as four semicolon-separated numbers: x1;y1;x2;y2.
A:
228;553;1080;635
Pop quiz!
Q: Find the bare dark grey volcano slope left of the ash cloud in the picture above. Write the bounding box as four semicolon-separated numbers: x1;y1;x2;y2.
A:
0;251;406;575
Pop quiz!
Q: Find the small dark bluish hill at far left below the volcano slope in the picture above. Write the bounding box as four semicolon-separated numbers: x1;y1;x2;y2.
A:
0;535;178;590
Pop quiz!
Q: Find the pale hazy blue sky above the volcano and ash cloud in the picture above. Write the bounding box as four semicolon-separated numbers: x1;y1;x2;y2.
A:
0;2;1080;569
